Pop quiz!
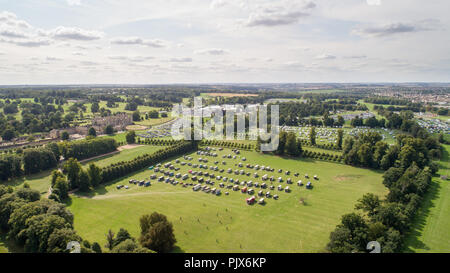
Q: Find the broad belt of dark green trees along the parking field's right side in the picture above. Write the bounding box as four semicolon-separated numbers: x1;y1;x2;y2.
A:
327;135;437;253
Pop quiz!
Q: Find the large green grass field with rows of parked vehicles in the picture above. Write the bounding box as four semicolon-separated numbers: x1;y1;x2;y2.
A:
68;150;387;252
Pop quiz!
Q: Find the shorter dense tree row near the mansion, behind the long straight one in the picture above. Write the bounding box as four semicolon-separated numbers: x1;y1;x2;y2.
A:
58;138;118;160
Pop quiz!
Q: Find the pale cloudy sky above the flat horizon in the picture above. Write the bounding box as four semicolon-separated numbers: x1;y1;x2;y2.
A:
0;0;450;85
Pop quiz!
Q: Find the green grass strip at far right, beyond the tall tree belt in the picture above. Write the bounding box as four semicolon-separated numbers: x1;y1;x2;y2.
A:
405;145;450;253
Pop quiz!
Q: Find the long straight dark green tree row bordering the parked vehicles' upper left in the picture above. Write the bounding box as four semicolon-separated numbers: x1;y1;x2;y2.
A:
101;141;197;183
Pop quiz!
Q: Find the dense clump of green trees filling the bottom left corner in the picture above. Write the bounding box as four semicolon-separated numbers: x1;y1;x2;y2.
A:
0;184;98;253
